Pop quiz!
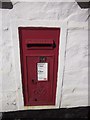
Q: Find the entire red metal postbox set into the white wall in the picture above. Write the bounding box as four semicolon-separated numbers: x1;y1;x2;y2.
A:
18;27;60;106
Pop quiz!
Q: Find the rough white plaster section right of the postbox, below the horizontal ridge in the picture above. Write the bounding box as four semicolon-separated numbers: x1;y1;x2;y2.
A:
62;29;88;107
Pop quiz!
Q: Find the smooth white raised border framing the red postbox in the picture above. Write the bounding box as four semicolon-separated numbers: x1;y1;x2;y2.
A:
11;20;67;110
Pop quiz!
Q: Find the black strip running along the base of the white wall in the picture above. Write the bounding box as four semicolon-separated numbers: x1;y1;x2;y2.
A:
2;107;90;120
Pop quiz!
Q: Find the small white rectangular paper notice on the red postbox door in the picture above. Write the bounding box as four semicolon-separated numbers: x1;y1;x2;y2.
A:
37;63;48;81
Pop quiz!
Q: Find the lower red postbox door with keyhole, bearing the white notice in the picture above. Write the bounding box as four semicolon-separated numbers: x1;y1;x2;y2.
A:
27;55;54;105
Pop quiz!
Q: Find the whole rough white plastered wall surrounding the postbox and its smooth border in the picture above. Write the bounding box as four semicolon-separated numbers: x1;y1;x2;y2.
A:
0;1;89;111
